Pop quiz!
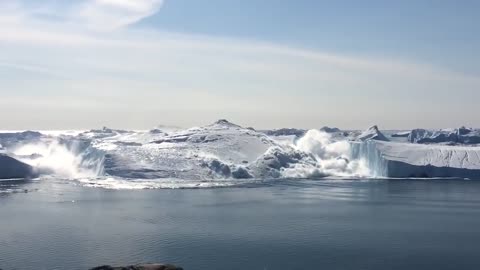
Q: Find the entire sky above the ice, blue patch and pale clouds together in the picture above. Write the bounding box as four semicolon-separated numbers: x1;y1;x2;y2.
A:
0;0;480;129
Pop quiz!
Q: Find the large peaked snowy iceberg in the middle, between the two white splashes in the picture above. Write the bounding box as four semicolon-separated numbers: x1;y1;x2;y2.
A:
92;119;277;181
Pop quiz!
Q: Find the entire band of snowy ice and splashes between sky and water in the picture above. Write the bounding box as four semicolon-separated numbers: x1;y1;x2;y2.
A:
0;120;480;188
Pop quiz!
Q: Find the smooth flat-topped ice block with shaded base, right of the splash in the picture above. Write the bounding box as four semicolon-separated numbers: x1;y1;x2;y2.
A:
352;141;480;179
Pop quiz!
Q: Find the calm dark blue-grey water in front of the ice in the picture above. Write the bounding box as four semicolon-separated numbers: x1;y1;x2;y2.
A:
0;179;480;270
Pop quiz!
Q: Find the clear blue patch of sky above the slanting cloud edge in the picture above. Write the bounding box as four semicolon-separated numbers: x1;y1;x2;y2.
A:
139;0;480;75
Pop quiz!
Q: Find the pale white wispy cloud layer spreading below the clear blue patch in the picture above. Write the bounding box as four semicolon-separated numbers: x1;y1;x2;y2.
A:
0;0;480;128
